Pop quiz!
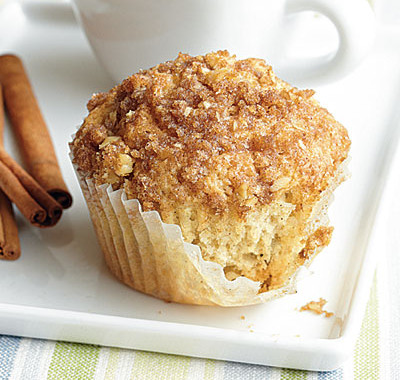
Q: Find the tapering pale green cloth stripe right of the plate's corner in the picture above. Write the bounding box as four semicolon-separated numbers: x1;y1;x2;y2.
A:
354;274;380;380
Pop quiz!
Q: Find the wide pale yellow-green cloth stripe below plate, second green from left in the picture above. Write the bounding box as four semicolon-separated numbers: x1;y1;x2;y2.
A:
131;351;191;380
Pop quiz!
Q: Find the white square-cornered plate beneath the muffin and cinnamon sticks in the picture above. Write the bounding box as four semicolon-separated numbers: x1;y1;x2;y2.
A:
0;3;400;369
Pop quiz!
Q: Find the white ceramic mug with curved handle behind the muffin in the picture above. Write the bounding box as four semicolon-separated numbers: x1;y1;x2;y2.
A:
74;0;375;85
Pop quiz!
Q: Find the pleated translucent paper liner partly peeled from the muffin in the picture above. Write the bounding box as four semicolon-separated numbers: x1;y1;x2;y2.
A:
75;156;347;306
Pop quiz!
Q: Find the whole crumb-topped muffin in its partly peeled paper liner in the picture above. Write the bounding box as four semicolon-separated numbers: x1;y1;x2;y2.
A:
70;51;350;306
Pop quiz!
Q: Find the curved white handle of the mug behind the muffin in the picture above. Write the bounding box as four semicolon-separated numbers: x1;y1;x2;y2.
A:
279;0;376;85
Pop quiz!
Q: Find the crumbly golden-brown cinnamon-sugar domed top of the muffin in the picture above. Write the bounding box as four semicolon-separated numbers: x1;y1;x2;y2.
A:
71;51;350;216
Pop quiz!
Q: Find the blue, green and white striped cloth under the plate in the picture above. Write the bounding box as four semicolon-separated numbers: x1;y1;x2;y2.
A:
0;270;382;380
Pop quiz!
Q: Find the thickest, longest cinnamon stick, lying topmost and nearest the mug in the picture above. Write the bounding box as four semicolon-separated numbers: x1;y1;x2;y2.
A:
0;55;72;208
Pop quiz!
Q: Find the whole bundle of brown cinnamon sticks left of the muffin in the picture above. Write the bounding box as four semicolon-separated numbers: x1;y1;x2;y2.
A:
0;55;72;260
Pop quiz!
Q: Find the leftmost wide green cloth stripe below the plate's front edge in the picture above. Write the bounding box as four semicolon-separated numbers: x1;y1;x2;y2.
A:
47;342;100;380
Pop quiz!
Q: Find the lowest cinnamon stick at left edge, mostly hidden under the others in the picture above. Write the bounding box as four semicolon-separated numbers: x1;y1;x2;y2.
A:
0;84;21;260
